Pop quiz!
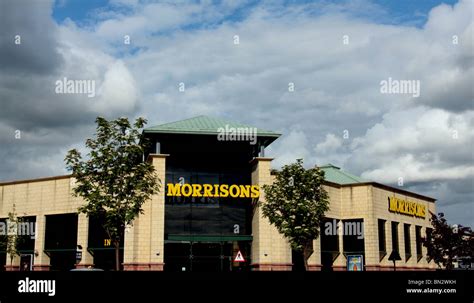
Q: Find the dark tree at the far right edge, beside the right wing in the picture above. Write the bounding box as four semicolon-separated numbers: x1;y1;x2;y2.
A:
423;212;474;270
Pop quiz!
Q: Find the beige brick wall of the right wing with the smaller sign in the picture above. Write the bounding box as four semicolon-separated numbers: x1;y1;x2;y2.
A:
309;184;436;269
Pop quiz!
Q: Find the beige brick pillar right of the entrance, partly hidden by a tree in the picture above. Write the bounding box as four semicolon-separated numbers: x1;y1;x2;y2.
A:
251;157;292;271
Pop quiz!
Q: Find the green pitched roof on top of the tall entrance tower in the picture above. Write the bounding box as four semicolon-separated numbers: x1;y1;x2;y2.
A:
143;116;280;138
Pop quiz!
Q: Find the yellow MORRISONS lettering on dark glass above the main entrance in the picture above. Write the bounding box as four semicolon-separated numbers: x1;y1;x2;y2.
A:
166;183;260;198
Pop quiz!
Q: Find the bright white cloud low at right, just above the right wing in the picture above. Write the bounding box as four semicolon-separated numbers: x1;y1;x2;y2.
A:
347;107;474;183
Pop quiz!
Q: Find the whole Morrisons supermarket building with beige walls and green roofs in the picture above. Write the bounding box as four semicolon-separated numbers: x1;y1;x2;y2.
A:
0;116;436;271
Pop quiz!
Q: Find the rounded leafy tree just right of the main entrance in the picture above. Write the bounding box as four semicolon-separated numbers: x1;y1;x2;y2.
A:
261;159;329;270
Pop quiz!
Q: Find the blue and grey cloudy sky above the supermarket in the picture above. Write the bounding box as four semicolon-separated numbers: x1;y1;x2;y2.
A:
0;0;474;226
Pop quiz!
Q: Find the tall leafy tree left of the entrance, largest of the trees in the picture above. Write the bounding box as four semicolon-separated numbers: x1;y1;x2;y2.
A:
65;117;161;270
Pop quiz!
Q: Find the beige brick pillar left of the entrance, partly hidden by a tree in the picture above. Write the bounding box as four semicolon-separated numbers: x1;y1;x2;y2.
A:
124;154;168;271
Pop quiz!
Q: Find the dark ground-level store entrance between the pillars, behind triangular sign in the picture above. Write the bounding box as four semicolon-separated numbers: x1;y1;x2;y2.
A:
164;241;250;272
